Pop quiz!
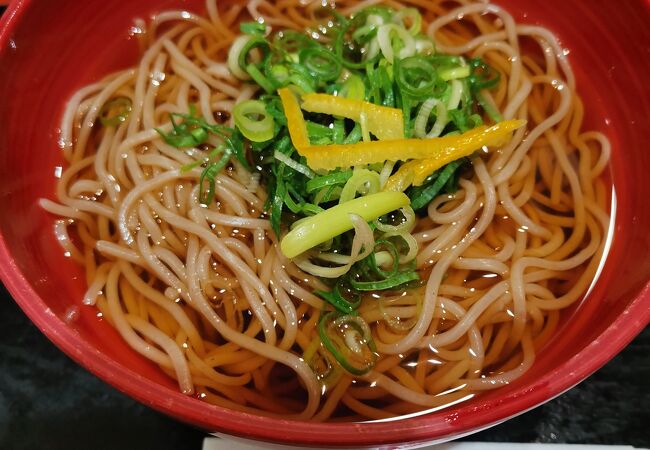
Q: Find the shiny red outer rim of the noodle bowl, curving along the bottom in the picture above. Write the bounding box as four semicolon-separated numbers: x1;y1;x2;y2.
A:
0;0;650;446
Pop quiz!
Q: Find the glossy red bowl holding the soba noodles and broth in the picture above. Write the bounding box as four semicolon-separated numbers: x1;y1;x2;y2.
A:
0;0;650;447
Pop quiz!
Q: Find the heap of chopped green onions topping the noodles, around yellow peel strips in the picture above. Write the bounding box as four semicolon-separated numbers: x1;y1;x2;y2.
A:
215;6;499;296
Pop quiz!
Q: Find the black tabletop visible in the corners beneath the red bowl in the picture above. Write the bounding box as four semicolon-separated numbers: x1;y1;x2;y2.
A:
0;0;650;450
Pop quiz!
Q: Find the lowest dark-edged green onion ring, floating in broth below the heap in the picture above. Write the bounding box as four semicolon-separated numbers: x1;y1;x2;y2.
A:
318;312;377;376
